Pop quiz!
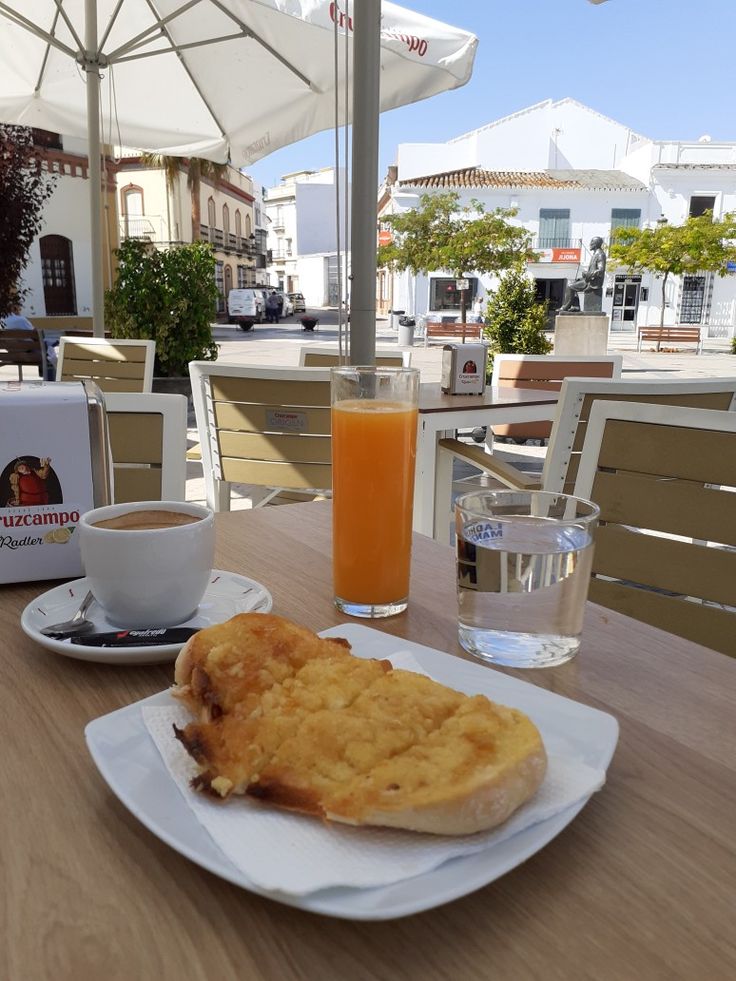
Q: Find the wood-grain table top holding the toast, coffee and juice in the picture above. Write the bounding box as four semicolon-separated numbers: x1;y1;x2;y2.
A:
0;504;736;981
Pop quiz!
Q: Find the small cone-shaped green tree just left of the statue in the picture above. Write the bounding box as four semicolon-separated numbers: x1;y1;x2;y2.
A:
483;265;552;372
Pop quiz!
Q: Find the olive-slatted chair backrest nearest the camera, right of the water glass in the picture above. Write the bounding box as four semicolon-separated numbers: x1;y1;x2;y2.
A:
575;402;736;656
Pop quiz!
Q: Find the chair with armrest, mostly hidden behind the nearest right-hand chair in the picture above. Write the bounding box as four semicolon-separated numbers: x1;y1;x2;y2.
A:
435;378;736;541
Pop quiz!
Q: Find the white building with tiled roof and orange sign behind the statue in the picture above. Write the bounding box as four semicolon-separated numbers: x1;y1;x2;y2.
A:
378;99;736;337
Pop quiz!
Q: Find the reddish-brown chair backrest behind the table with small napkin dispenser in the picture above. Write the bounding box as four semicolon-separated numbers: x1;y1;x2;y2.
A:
491;354;623;439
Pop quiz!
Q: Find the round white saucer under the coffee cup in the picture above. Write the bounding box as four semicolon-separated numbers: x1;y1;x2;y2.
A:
20;569;273;664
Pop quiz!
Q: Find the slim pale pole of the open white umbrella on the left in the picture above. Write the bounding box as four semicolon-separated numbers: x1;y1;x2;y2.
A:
84;0;105;337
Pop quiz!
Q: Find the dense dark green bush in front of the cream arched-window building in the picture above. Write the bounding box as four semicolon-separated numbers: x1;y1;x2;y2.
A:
105;239;217;376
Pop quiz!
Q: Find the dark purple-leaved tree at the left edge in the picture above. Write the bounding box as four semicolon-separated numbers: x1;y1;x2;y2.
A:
0;124;58;317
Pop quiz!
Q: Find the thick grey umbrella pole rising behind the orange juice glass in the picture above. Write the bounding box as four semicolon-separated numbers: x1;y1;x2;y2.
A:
350;0;381;364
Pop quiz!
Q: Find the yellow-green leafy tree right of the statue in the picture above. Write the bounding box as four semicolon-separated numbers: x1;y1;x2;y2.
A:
609;212;736;327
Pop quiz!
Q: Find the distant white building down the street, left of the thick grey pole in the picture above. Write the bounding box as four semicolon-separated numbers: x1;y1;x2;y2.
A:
265;167;350;307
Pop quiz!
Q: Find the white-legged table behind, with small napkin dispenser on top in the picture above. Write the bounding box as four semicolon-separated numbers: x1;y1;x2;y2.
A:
414;382;560;535
